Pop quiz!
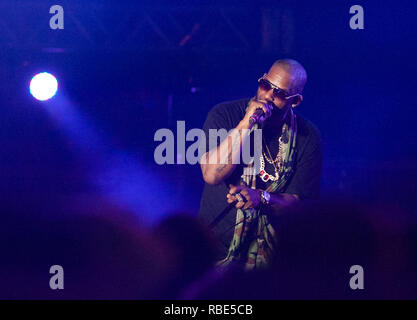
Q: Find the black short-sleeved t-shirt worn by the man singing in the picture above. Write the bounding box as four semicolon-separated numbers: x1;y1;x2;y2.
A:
198;99;322;259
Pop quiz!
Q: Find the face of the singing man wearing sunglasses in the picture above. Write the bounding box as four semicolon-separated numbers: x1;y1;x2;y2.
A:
256;66;292;112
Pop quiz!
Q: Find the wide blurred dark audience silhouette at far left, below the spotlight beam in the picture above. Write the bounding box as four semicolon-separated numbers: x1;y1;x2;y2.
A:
0;200;173;299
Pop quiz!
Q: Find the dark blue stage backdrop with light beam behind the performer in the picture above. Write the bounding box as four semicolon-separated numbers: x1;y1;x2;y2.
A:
0;0;417;224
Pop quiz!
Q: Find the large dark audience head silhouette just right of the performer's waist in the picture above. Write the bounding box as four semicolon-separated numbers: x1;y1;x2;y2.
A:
272;201;376;299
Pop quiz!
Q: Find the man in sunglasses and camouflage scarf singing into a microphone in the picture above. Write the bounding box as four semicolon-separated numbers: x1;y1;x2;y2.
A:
199;59;322;269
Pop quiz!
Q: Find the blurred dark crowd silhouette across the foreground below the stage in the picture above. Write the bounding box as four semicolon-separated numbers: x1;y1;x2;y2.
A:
0;195;417;300
